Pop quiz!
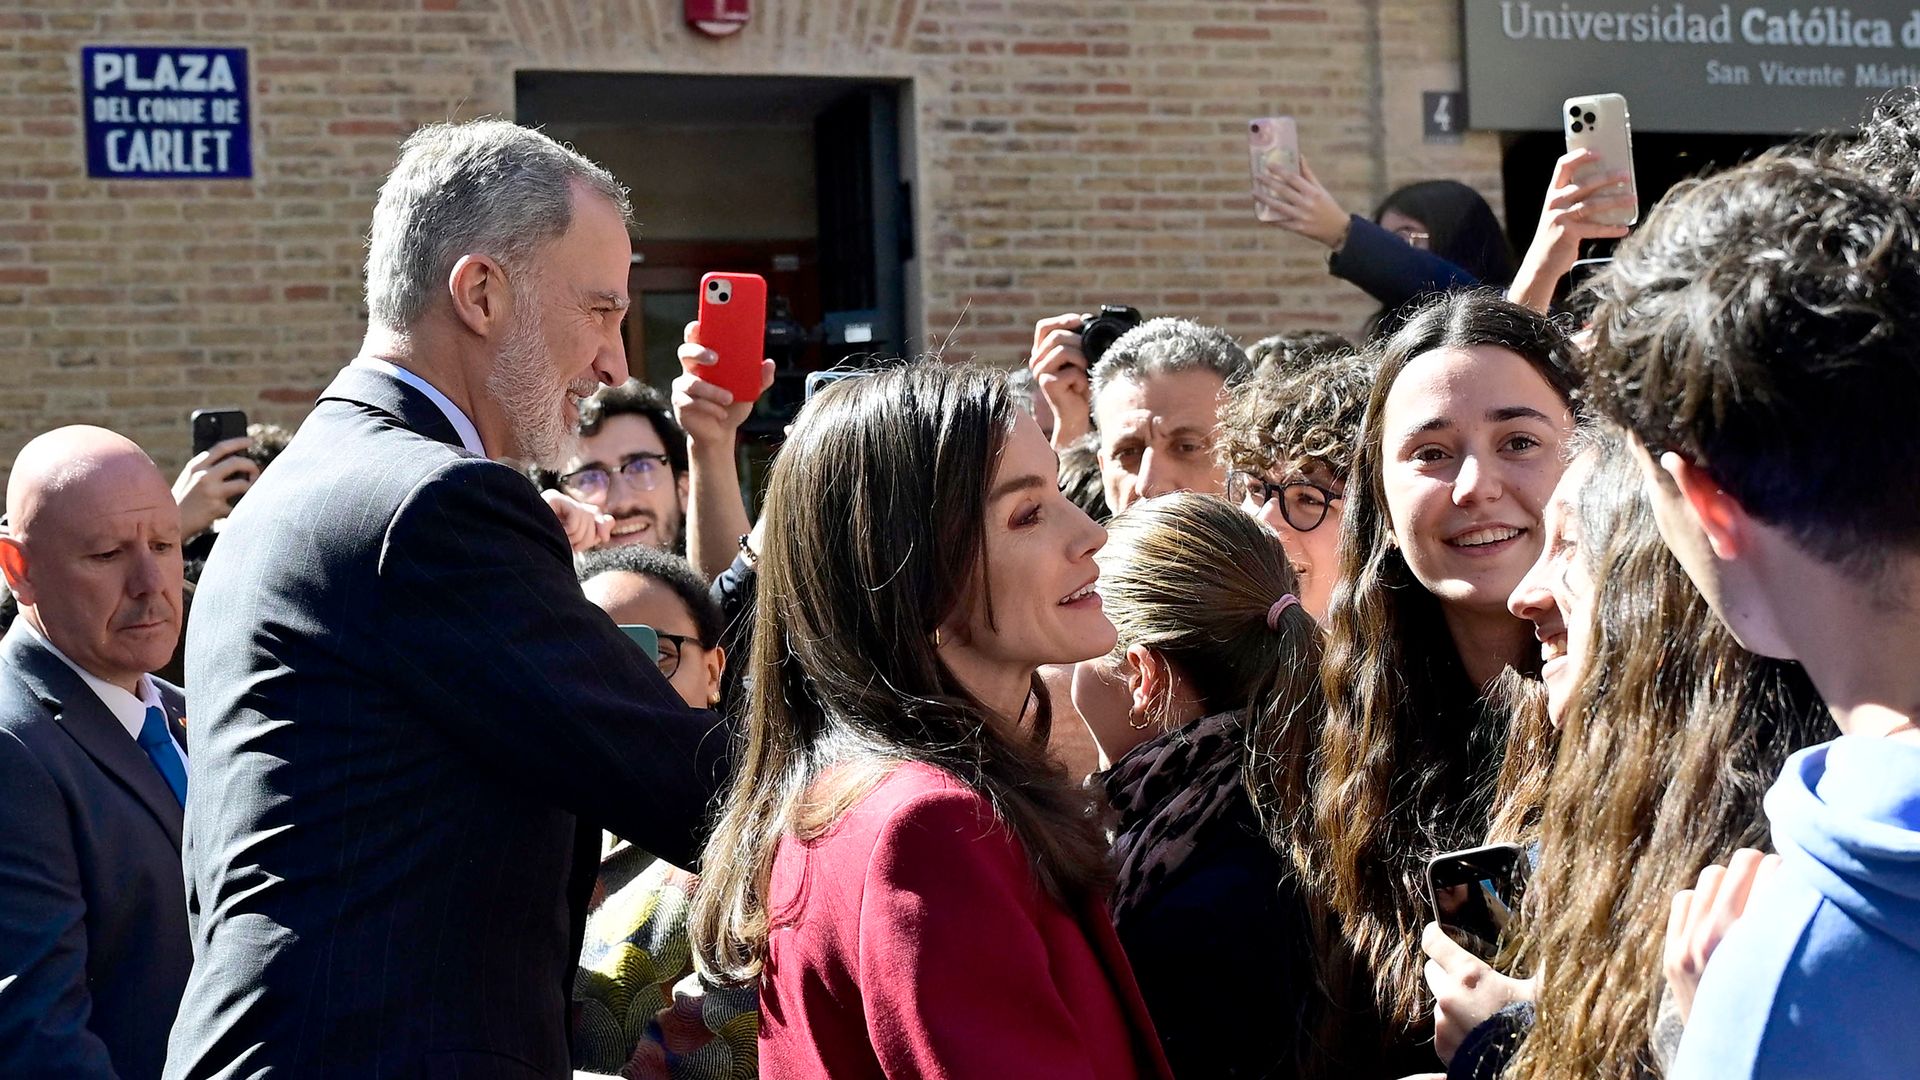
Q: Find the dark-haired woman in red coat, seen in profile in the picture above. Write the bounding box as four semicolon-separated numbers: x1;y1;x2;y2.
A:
691;363;1167;1080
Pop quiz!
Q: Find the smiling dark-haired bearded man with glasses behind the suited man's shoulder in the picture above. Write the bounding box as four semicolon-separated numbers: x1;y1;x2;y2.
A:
536;379;687;552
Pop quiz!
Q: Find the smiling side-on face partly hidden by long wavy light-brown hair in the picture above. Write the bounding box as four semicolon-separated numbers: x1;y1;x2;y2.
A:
1507;445;1596;726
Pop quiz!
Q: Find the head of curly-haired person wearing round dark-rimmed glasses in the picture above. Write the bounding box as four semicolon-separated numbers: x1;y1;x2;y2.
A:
1221;354;1373;621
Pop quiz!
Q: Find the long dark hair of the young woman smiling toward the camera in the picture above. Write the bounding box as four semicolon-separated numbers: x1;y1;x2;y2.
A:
1300;290;1574;1028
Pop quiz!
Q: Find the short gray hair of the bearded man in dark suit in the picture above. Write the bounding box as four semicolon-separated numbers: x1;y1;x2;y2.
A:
367;119;632;332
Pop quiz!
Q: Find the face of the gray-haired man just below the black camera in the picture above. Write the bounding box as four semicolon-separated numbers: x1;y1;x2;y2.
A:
1092;369;1227;513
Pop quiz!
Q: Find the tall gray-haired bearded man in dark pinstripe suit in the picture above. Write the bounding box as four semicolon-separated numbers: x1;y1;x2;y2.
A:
167;121;726;1078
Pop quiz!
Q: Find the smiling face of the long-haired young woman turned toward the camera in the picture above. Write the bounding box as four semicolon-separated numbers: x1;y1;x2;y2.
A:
1380;346;1572;613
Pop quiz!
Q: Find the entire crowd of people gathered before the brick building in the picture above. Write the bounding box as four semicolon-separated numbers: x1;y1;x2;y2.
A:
0;96;1920;1080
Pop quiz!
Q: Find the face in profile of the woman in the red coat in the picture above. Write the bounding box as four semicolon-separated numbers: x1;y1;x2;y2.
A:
939;409;1114;701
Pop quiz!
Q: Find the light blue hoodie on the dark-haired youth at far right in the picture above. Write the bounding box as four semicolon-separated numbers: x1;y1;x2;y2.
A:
1670;736;1920;1080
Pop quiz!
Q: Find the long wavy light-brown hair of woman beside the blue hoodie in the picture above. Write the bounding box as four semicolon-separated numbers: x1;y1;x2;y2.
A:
1507;427;1830;1080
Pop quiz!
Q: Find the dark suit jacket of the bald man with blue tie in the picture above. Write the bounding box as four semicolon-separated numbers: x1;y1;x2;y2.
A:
0;621;194;1078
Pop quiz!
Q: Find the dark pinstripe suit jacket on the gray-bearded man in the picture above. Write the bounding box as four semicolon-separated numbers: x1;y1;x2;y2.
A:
167;367;726;1078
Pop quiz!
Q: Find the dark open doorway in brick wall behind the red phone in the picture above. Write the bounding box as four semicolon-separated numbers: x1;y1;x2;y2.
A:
515;71;916;492
